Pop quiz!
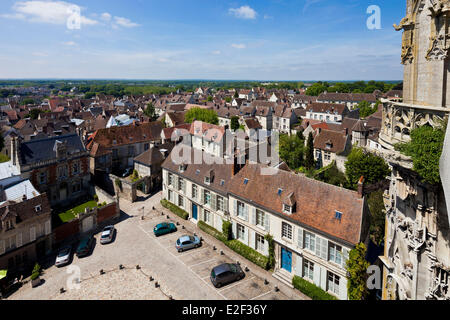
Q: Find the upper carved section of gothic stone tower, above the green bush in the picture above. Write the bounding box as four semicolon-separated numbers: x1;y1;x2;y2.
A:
380;0;450;150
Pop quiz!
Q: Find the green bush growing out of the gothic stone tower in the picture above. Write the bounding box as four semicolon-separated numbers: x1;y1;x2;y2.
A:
395;119;448;184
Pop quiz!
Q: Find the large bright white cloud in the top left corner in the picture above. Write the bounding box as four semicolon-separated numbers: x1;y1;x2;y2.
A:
2;1;98;25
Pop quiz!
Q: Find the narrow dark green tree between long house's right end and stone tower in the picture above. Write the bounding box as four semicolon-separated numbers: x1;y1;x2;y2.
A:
367;190;386;246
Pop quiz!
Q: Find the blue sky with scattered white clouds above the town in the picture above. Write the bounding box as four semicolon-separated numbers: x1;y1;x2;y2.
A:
0;0;406;80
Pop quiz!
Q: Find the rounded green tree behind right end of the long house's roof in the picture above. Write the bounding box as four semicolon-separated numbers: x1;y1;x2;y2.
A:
345;147;391;189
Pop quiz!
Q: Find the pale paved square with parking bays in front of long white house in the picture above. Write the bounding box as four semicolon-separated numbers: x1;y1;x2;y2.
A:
9;194;306;300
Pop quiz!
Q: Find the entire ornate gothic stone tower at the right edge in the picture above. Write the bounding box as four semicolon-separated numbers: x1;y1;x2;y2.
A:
380;0;450;300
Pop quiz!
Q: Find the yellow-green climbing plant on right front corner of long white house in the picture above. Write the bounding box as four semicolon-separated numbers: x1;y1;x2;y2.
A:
345;243;370;300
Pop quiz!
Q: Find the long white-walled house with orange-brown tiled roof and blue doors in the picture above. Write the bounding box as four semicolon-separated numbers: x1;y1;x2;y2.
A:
162;148;369;300
